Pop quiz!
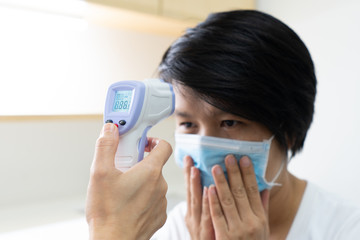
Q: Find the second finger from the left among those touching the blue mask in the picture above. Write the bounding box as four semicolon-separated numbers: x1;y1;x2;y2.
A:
190;166;201;223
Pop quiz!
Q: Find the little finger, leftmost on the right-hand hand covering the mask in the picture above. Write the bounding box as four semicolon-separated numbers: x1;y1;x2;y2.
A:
208;185;227;235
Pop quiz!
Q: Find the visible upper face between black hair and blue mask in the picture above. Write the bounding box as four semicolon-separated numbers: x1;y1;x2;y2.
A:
174;85;284;182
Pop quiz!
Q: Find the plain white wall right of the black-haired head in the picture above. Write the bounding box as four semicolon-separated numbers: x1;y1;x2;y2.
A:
257;0;360;204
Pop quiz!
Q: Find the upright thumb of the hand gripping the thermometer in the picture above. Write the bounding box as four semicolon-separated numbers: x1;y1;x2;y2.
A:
92;123;119;171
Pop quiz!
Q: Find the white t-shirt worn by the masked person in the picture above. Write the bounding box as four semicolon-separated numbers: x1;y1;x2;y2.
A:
152;183;360;240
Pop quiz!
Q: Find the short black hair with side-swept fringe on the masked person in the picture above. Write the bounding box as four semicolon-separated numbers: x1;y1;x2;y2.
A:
159;10;316;156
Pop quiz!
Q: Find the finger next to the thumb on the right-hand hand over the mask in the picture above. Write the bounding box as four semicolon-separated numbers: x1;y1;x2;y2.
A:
240;156;264;216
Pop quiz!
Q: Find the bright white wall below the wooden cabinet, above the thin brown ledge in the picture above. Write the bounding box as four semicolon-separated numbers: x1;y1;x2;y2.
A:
0;4;175;116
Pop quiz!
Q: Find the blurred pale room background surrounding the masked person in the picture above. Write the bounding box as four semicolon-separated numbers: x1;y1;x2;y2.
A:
0;0;360;240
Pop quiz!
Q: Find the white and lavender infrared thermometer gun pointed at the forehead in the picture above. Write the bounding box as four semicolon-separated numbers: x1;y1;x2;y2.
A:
104;79;175;171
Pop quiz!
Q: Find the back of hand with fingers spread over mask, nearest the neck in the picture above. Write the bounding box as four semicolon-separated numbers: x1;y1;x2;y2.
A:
209;155;270;240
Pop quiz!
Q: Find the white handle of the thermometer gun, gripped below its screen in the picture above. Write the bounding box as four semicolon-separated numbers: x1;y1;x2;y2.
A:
115;124;150;172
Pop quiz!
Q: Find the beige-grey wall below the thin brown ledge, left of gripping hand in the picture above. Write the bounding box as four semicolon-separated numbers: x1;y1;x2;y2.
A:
0;118;102;207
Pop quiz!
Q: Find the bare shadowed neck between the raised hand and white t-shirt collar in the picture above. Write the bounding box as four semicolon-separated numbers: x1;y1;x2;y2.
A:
269;169;306;239
